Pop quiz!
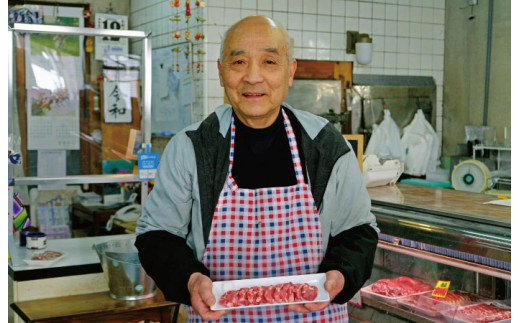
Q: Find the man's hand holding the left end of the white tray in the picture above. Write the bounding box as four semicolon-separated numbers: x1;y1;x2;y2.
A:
188;273;226;321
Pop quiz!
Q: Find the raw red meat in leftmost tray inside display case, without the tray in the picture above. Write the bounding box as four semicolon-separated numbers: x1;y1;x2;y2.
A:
370;276;431;297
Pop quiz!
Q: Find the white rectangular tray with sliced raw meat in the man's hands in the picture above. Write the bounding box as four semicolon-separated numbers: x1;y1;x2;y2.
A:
211;273;330;310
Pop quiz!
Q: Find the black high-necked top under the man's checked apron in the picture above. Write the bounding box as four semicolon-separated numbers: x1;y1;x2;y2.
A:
232;110;303;189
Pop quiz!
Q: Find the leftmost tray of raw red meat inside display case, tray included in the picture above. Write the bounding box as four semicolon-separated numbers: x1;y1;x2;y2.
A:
361;276;433;305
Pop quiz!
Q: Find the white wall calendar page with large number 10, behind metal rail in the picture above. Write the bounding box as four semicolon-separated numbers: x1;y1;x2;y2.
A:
95;13;128;60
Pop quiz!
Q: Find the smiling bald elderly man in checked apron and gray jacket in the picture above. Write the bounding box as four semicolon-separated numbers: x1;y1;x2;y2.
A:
136;16;378;322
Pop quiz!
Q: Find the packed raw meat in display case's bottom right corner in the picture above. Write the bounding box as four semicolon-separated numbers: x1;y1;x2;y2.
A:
442;301;511;323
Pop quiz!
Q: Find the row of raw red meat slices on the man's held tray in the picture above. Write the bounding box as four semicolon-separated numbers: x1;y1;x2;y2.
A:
219;282;318;307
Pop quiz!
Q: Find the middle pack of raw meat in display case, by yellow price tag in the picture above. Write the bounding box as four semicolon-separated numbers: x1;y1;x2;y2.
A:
397;291;484;317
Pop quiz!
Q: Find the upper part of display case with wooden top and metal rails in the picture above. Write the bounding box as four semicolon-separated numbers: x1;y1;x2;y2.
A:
368;184;511;279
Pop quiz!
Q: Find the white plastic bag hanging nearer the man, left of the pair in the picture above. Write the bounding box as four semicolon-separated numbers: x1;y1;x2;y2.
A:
365;110;405;162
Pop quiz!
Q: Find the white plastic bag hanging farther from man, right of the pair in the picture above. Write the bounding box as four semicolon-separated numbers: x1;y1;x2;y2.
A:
401;109;440;176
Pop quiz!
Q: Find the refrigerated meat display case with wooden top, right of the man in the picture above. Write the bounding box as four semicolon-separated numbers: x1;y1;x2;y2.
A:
349;184;511;322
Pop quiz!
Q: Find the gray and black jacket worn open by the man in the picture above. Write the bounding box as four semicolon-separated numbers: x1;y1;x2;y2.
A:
136;105;379;305
